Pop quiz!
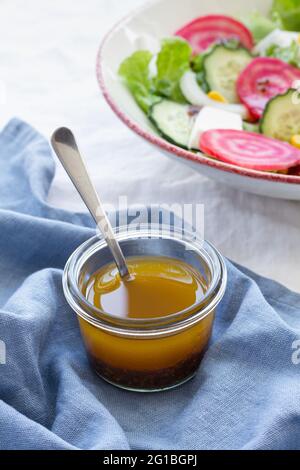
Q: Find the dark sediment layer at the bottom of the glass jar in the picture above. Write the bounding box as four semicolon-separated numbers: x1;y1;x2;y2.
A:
89;350;205;391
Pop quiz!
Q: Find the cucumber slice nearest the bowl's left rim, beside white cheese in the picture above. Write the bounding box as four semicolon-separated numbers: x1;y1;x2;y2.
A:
149;100;197;149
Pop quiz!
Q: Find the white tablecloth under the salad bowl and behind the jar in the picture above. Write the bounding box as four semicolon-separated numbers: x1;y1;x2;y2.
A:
0;0;300;292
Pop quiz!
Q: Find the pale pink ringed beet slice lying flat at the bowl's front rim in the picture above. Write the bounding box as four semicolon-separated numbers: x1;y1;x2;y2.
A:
200;129;300;171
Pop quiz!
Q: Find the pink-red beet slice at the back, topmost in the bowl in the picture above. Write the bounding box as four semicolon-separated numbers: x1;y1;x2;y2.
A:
175;15;254;53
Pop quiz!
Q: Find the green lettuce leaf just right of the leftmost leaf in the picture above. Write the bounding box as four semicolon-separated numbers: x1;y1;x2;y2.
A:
154;38;192;103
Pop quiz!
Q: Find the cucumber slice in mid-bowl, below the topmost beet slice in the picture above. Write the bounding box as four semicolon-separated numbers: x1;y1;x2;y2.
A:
203;44;253;103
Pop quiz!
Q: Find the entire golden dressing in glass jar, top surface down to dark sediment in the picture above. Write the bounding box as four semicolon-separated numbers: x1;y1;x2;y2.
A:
79;256;213;391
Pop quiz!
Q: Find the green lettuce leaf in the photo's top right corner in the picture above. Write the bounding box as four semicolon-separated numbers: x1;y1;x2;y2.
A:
272;0;300;31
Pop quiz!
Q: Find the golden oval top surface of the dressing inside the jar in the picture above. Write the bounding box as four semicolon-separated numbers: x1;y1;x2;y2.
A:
85;257;205;318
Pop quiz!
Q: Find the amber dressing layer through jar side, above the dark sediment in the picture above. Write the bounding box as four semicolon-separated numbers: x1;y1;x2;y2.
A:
79;312;214;371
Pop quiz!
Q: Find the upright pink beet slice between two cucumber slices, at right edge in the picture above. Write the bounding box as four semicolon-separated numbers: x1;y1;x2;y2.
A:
237;57;300;119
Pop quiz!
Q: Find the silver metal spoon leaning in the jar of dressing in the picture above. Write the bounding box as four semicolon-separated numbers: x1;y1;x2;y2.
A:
51;127;129;277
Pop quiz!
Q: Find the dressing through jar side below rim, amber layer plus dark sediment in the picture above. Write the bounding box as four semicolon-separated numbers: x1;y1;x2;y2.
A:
78;302;214;391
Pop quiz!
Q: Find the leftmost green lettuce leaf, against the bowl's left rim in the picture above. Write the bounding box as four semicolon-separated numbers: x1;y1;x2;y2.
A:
119;51;160;113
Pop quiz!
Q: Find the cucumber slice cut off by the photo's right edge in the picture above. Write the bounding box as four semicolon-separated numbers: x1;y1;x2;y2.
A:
260;88;300;142
